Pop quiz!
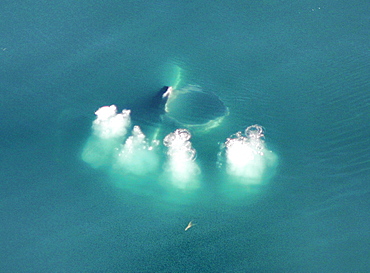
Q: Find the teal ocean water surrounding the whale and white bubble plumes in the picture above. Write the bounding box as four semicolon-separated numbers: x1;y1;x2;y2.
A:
0;0;370;273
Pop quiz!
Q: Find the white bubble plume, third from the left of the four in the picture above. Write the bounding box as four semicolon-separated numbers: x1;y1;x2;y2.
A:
163;129;200;189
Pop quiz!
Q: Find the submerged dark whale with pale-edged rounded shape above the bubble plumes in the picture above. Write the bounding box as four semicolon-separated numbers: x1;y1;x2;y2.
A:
131;63;229;140
